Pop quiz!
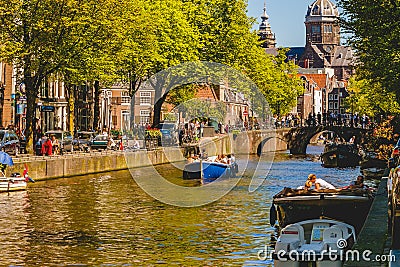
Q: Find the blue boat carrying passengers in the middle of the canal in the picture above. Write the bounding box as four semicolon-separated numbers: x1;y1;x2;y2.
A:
183;161;238;183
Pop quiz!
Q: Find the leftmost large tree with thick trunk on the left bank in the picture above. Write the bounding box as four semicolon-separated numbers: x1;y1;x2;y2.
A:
0;0;119;152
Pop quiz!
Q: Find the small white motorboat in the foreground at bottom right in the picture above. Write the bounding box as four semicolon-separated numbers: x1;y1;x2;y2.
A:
272;219;356;267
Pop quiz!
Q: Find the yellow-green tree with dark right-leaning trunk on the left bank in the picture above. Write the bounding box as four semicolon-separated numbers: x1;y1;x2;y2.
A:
145;0;201;125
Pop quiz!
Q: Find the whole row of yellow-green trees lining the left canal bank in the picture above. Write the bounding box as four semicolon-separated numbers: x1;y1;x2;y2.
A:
0;0;301;155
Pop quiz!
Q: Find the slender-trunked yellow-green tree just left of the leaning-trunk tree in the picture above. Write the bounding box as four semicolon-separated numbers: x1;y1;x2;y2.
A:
115;0;160;130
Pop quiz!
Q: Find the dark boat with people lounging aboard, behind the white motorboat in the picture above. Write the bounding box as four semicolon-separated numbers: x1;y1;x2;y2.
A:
270;187;374;230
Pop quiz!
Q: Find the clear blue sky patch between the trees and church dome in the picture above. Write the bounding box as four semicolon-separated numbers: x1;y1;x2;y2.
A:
247;0;337;47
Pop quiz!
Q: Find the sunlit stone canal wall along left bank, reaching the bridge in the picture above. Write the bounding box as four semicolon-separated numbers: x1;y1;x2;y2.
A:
6;130;287;180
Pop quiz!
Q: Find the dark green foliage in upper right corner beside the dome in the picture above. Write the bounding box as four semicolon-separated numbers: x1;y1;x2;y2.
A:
339;0;400;102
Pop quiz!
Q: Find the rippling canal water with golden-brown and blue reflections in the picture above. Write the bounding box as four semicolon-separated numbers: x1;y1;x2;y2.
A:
0;146;366;266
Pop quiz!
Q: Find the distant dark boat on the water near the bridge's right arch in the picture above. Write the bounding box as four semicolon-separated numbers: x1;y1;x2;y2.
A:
321;143;361;168
